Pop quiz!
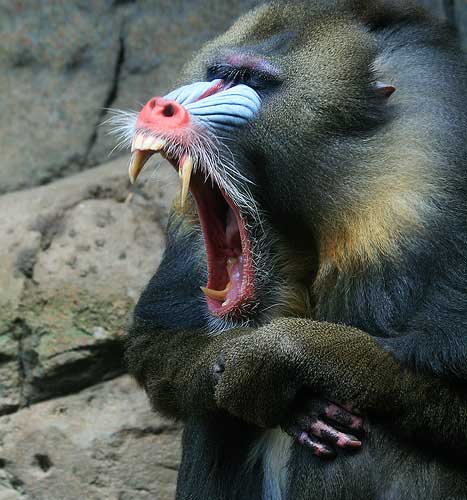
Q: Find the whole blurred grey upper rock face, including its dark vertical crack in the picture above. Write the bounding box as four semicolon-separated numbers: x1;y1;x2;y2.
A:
0;0;258;192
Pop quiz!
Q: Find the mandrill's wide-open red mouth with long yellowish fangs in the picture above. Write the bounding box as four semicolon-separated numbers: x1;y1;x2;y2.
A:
129;134;254;317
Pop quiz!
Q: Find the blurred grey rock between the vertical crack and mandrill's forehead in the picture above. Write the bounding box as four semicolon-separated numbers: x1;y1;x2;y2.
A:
89;0;261;168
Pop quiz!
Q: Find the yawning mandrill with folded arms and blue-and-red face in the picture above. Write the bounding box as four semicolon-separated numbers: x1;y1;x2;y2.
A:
116;0;467;500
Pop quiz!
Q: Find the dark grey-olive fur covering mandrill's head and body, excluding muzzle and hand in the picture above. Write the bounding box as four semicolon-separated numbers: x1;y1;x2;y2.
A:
126;1;467;500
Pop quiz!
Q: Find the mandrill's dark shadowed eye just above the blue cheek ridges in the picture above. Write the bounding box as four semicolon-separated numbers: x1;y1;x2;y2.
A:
207;64;279;90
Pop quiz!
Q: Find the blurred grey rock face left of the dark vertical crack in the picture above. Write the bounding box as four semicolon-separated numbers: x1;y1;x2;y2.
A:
0;0;121;192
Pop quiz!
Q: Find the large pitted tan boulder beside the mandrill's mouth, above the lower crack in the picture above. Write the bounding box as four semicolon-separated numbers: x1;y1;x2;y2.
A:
0;160;178;413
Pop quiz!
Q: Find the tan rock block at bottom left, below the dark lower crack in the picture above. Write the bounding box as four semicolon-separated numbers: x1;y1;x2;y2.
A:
0;376;180;500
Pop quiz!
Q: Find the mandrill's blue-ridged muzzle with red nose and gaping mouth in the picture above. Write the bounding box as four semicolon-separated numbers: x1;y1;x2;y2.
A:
129;79;261;315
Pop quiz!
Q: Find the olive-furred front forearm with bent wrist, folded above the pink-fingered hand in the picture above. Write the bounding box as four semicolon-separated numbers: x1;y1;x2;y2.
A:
215;318;467;451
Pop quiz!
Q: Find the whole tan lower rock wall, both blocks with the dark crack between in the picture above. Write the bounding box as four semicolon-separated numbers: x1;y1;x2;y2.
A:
0;160;179;500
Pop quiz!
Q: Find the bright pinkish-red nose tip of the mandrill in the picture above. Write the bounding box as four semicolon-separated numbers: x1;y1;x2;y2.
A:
137;97;190;132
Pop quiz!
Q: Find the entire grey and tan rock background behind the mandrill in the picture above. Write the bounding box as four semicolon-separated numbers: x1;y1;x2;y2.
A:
0;0;467;500
